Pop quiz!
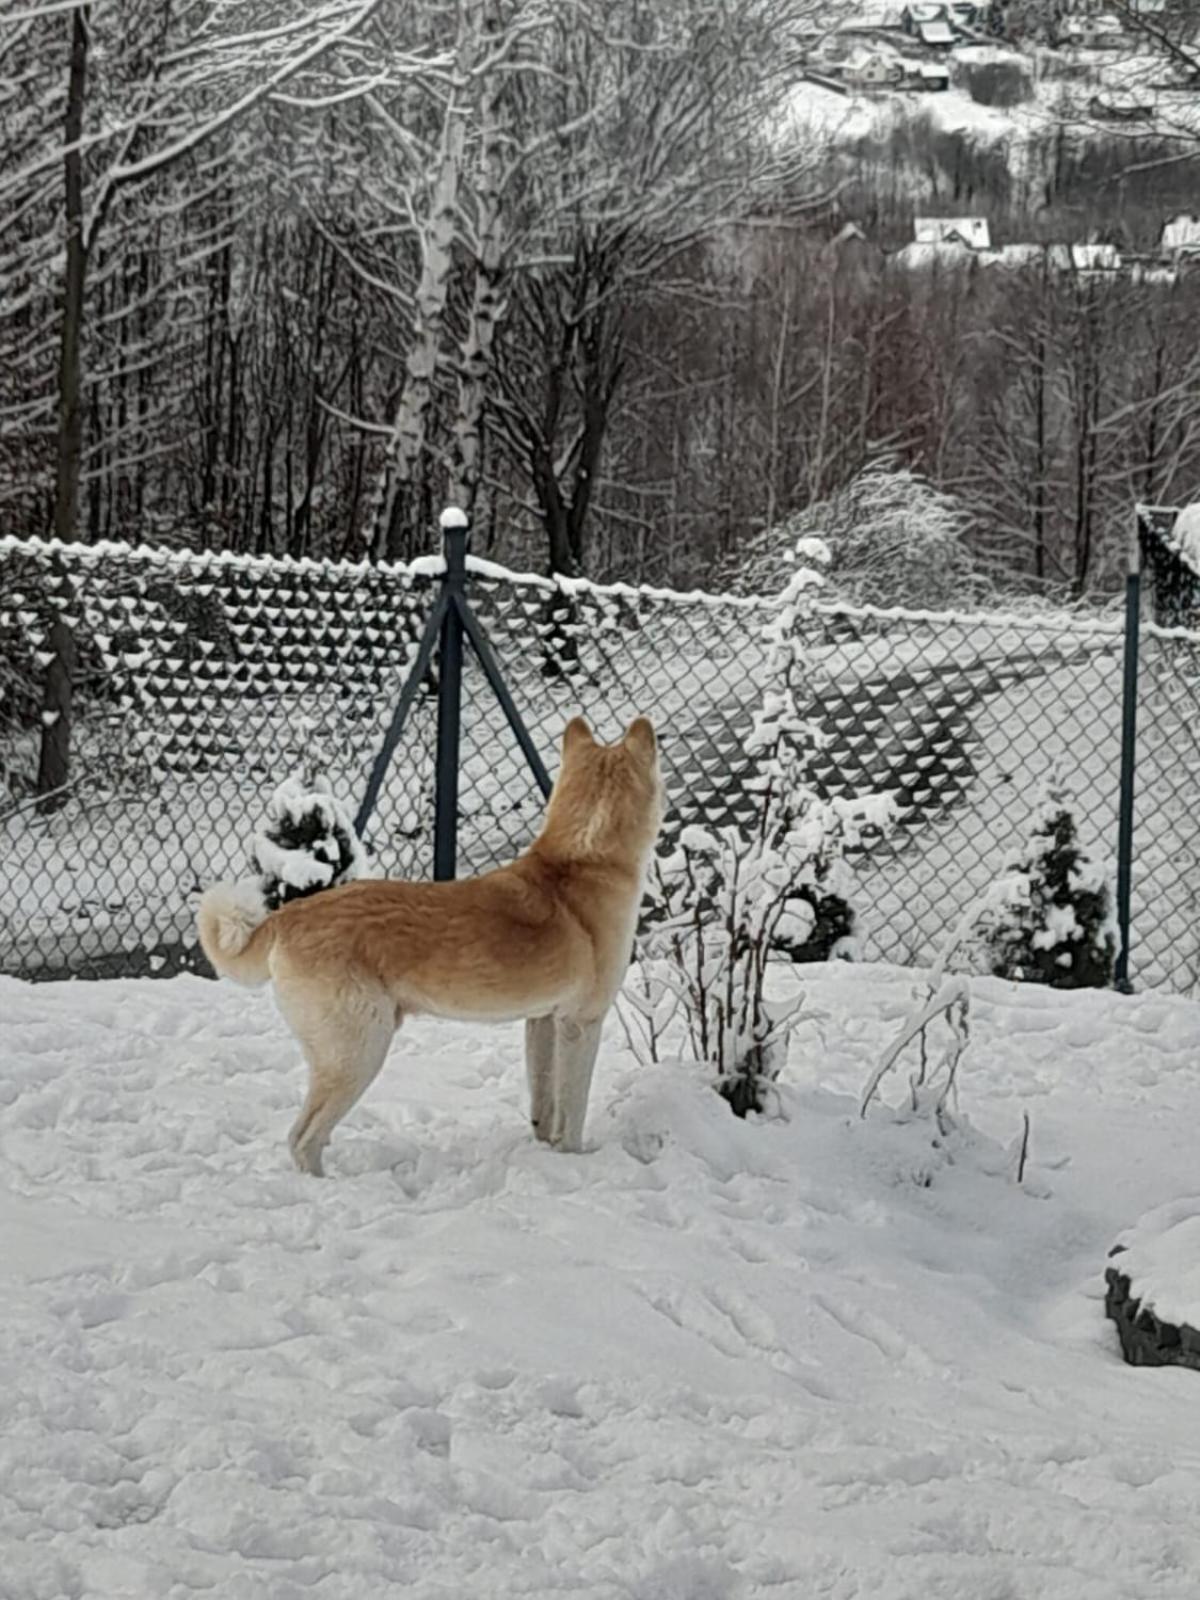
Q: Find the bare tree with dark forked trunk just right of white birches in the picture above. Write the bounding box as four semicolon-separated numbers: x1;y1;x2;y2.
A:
483;0;825;573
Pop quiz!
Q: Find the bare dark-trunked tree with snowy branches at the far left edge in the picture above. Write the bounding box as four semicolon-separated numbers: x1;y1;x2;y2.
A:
0;0;438;789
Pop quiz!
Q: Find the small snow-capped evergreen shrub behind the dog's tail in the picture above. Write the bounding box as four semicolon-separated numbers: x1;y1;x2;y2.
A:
253;778;366;910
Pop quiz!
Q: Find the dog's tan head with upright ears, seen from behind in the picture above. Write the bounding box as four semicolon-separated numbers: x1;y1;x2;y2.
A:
546;717;664;861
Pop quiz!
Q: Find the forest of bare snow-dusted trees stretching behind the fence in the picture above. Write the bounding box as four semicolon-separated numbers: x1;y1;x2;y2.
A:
0;0;1200;595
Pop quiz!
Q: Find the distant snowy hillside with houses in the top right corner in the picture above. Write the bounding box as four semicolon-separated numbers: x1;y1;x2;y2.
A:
782;0;1200;250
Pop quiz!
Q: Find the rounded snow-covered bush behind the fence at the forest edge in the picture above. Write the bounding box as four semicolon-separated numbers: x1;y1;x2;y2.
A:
720;461;979;610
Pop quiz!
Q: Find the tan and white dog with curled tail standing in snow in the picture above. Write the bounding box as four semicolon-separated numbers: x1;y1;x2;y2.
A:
200;717;662;1176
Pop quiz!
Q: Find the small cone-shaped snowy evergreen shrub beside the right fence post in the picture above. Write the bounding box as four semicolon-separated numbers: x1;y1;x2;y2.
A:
974;776;1117;989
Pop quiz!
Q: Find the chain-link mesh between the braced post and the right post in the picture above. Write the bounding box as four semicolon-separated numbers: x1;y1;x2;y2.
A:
461;578;1123;963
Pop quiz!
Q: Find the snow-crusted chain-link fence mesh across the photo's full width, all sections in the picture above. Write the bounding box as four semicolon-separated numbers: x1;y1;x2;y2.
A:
0;508;1200;992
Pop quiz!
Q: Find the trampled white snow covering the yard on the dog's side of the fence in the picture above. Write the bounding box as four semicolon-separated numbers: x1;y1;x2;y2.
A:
0;968;1200;1600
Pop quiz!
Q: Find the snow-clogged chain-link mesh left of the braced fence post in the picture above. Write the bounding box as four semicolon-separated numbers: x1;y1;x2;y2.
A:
0;541;437;976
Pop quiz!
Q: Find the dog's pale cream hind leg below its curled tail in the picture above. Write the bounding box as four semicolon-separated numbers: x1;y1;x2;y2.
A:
277;987;397;1178
